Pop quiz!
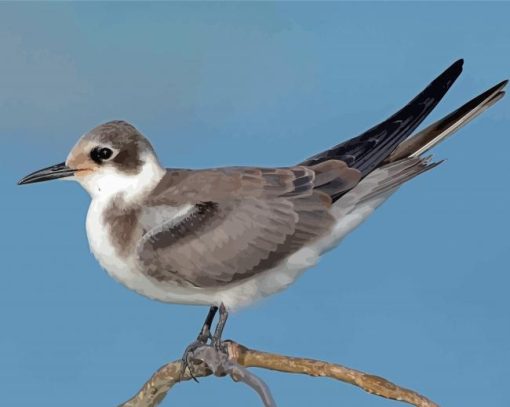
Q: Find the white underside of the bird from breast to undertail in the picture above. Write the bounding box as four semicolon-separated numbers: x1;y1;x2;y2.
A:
87;171;395;309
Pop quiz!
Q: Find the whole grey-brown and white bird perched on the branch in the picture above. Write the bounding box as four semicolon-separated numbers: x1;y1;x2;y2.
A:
18;59;508;374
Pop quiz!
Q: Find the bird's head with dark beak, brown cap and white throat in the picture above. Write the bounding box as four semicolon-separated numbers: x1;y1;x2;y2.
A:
18;121;164;201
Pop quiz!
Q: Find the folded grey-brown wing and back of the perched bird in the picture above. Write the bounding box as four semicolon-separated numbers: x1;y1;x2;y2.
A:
137;160;361;287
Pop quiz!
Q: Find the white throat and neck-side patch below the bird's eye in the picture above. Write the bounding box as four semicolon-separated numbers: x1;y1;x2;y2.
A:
75;154;166;202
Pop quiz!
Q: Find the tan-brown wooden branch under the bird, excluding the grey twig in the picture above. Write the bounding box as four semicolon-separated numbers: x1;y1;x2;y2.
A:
119;341;438;407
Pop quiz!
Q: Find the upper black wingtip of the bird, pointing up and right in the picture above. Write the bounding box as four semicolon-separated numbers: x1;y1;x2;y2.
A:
301;59;464;176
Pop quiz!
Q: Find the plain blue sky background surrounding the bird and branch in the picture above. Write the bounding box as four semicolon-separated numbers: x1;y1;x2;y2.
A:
0;2;510;407
